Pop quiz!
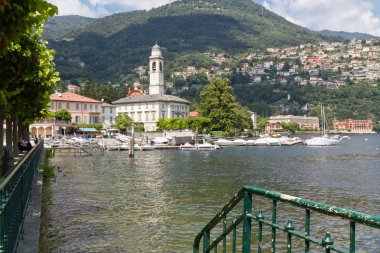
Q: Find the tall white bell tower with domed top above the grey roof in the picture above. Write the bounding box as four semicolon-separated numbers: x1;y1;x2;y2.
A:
149;44;165;95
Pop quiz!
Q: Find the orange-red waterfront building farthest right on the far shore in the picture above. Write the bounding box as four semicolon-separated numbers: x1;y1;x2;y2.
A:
334;118;373;133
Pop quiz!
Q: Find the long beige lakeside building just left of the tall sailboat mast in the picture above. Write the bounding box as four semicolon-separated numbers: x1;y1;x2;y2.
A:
265;115;319;133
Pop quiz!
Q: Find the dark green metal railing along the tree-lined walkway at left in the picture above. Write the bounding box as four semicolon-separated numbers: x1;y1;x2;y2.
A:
0;141;44;253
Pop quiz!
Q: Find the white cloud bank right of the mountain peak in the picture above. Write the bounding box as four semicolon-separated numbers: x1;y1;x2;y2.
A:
263;0;380;36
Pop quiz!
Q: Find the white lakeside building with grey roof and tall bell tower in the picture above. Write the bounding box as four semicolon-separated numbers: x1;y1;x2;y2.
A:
112;44;191;132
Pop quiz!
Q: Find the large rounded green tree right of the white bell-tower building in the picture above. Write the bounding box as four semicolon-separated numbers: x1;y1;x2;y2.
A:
200;77;250;133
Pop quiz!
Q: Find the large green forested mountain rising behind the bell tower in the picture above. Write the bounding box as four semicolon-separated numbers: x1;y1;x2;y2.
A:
46;0;336;83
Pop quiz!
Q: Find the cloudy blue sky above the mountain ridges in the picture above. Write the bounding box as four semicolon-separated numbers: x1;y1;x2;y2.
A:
47;0;380;36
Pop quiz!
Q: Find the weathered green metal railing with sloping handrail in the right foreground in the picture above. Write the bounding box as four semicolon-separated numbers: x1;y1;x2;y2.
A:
193;186;380;253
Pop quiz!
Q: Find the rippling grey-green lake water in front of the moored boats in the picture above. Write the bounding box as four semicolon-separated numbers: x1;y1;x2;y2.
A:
50;134;380;253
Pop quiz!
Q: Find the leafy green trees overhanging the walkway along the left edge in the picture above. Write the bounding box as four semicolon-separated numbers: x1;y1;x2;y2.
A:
0;0;58;155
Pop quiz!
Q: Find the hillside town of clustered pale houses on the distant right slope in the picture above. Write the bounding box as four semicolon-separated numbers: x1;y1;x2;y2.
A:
162;39;380;89
